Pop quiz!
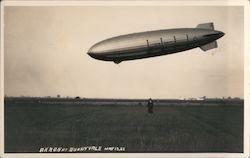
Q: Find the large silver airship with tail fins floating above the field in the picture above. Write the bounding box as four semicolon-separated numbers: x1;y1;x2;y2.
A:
87;23;224;64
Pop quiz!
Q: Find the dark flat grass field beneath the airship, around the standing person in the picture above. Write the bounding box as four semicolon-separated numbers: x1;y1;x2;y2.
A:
4;98;243;153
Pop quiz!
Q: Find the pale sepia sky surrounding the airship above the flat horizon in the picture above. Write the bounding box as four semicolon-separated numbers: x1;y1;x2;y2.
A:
4;6;244;99
